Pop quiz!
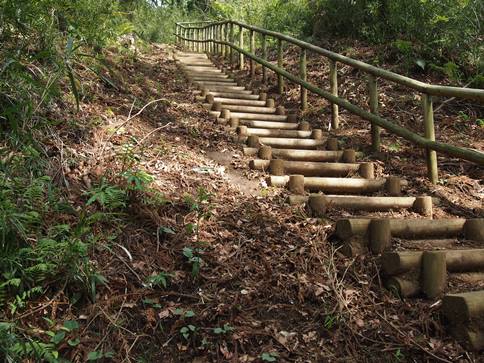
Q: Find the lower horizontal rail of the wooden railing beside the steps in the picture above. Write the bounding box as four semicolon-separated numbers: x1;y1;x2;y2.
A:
179;36;484;165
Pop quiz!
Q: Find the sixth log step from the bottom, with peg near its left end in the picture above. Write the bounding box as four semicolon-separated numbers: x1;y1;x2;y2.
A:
249;159;361;177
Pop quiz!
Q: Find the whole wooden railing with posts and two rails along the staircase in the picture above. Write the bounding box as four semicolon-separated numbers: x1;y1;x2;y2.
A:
175;20;484;184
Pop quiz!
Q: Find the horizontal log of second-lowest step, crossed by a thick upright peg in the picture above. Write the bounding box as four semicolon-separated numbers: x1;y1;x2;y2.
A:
381;249;484;276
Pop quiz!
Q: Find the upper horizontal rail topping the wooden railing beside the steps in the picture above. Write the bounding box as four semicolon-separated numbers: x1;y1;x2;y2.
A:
176;20;484;104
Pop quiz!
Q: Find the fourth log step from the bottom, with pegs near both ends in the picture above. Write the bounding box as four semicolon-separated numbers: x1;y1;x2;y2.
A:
288;194;432;216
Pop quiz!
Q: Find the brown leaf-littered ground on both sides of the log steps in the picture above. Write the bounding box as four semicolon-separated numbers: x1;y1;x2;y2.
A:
8;41;484;362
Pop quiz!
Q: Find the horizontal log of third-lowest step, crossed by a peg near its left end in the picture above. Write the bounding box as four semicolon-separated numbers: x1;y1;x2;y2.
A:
336;218;484;242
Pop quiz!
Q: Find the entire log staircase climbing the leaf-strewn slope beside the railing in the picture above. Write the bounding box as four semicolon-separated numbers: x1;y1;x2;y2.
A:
175;52;484;350
